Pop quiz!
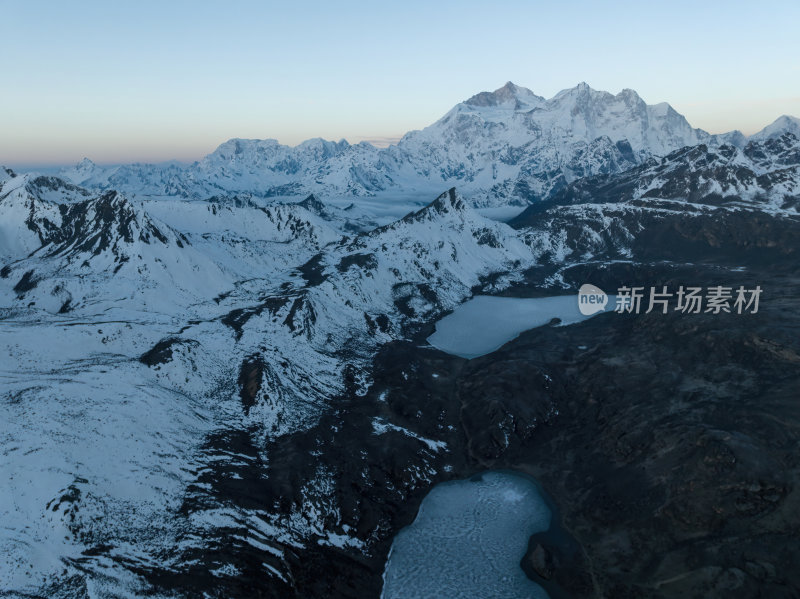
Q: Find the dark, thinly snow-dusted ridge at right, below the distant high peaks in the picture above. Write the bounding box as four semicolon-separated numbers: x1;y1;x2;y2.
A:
510;133;800;278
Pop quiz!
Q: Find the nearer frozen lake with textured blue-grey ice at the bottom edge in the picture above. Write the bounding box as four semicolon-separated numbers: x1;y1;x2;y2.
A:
382;472;551;599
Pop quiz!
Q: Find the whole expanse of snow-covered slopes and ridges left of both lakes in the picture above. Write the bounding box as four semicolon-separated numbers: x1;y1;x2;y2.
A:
0;173;547;596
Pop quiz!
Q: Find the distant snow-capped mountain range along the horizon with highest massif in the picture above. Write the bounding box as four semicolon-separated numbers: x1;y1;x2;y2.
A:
54;82;797;206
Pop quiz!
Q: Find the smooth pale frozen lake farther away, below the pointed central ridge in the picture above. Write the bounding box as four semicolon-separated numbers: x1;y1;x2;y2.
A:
428;295;616;358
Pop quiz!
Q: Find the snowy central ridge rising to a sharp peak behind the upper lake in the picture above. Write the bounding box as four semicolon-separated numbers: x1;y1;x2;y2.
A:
203;190;543;433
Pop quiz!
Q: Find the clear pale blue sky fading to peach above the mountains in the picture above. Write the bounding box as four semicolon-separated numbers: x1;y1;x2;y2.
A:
0;0;800;166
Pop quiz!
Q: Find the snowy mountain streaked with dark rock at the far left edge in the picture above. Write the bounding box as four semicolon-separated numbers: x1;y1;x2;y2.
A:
0;175;230;313
